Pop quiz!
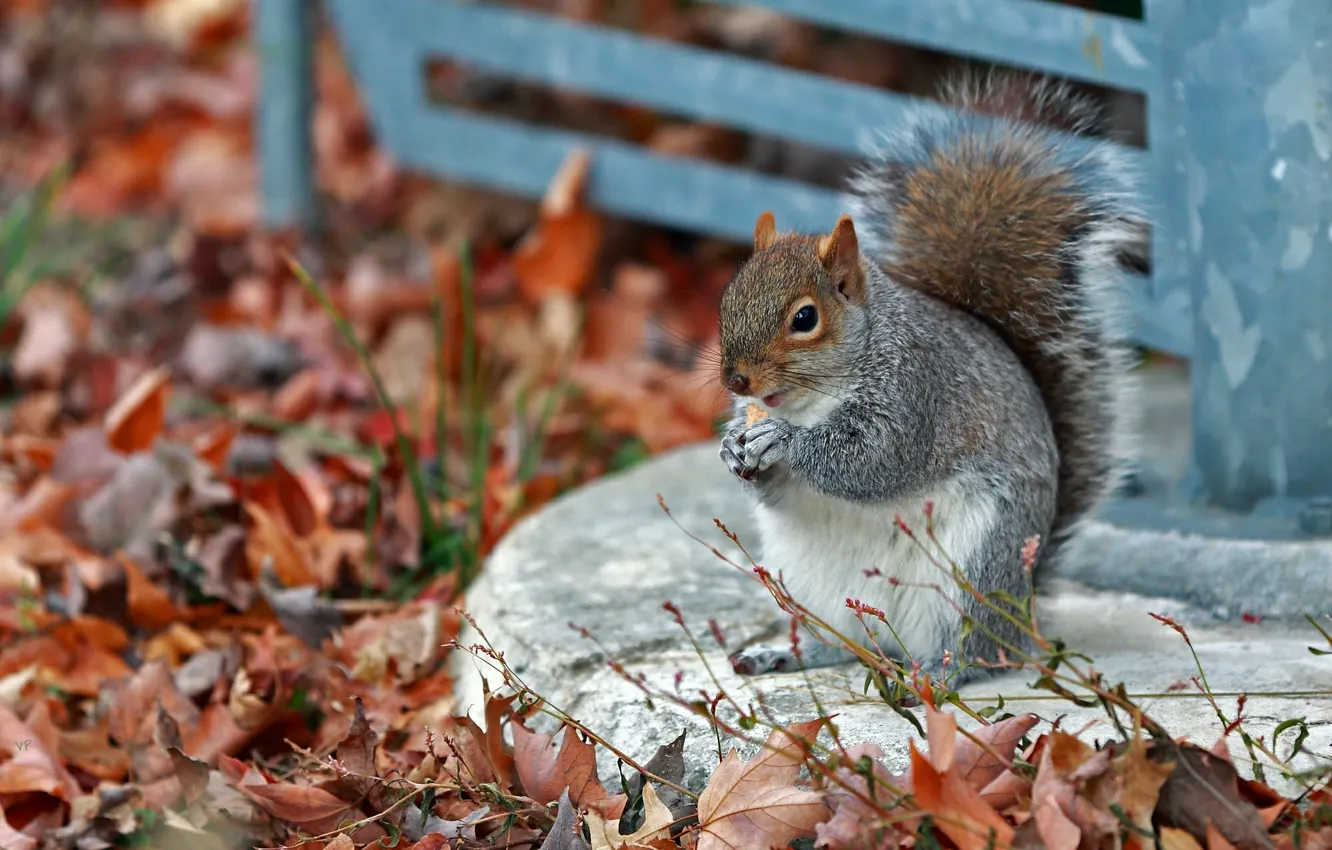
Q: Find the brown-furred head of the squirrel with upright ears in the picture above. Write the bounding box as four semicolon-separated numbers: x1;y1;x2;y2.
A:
721;212;866;404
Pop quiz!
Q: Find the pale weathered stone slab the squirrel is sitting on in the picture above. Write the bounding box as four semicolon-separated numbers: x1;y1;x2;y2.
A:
457;445;1332;786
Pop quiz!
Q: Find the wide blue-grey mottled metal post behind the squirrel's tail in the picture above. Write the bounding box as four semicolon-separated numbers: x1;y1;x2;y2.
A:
1150;0;1332;512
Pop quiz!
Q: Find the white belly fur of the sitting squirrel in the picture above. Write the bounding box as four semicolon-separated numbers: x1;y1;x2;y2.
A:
757;480;996;662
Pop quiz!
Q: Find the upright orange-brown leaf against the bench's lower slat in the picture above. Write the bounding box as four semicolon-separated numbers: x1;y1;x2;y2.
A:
513;151;605;301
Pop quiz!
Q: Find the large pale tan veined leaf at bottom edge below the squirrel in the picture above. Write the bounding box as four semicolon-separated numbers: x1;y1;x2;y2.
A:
698;719;833;850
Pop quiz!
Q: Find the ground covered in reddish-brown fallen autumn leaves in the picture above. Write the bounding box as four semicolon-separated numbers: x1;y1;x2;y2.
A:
0;0;1332;850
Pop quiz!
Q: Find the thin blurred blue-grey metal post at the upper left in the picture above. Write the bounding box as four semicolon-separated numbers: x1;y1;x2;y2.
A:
253;0;314;228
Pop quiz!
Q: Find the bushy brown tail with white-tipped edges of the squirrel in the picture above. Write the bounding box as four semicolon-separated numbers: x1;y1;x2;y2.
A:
848;76;1146;580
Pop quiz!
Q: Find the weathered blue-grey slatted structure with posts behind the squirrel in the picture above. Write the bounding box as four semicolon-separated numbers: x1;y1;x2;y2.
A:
256;0;1332;538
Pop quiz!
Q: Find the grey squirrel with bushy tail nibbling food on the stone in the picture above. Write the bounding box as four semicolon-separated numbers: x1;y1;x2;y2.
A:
719;73;1146;686
